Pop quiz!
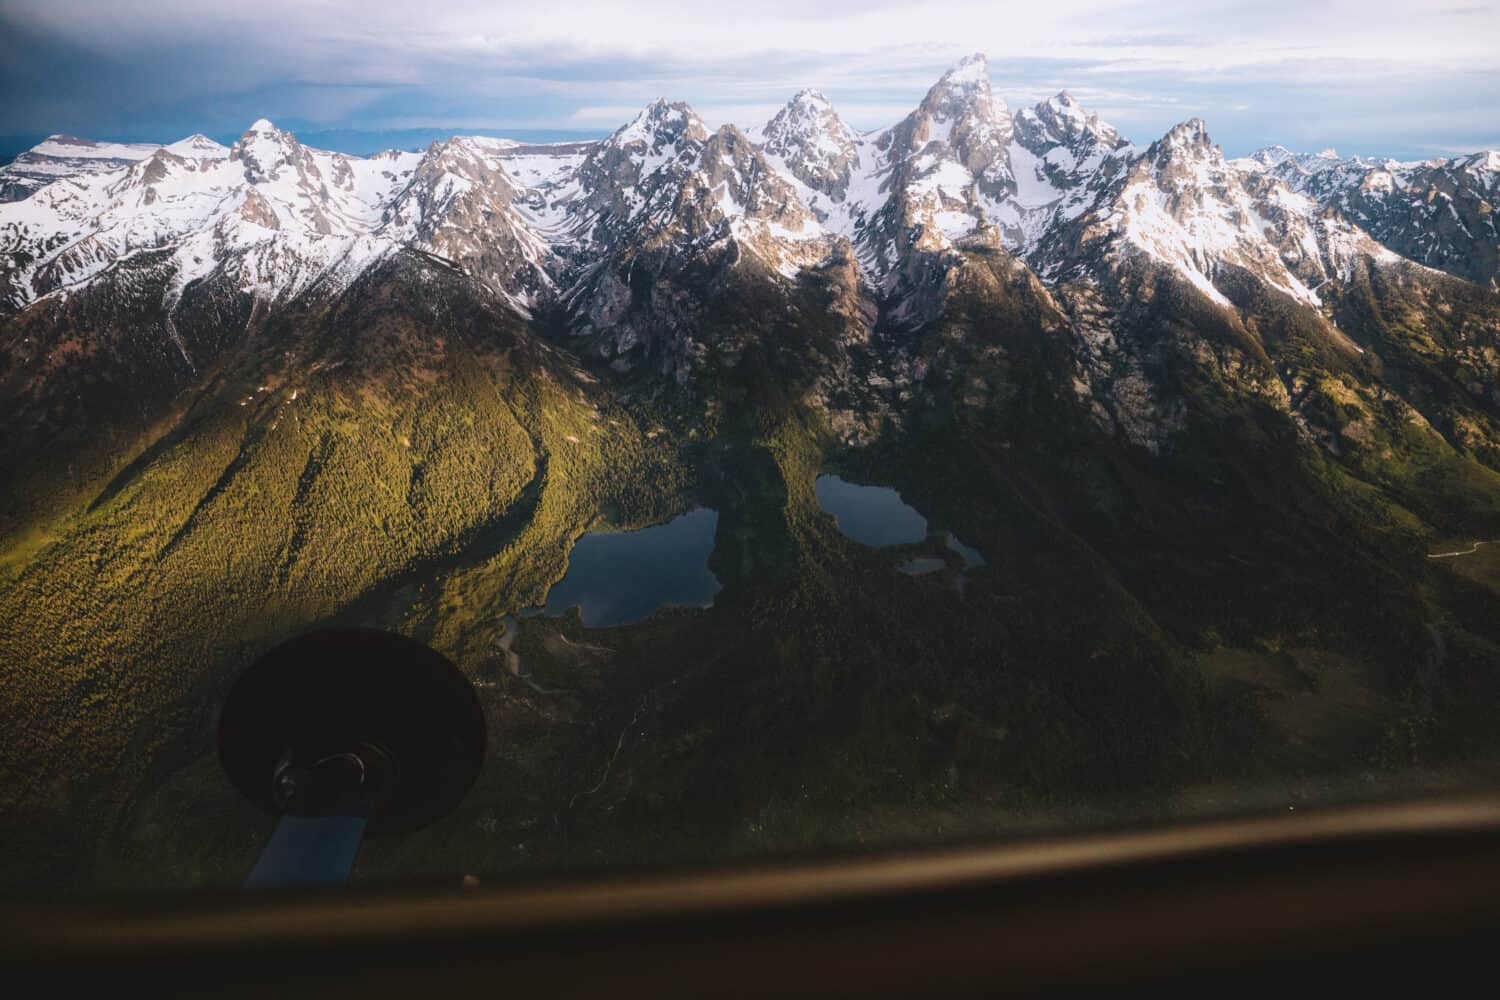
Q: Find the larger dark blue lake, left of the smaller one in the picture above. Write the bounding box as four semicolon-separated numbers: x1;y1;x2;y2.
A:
543;507;719;628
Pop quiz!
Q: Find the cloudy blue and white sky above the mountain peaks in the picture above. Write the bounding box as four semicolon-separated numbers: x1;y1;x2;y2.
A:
0;0;1500;156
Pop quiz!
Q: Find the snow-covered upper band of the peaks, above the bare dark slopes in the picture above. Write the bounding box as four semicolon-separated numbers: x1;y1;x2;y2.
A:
0;55;1500;340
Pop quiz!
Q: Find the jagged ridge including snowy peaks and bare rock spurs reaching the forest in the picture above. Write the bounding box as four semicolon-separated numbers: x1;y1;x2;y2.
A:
0;55;1500;448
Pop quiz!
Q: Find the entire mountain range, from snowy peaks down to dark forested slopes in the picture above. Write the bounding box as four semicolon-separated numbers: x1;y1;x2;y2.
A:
0;55;1500;880
